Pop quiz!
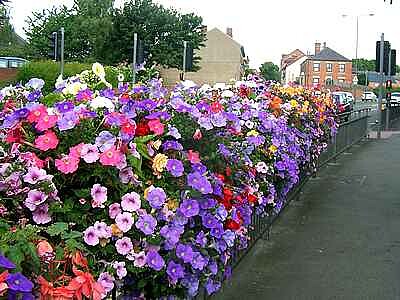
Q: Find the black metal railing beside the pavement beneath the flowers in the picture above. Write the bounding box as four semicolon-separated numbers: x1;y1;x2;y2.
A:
112;109;370;300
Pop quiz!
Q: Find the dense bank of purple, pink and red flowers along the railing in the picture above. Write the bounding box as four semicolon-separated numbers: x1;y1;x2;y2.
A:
0;64;337;299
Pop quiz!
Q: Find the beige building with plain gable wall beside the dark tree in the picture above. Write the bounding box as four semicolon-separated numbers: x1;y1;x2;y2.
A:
160;28;248;85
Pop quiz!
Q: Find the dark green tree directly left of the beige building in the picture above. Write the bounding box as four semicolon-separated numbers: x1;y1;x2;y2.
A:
104;0;205;68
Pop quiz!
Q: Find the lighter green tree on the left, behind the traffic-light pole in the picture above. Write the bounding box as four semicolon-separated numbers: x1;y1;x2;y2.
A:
25;0;114;61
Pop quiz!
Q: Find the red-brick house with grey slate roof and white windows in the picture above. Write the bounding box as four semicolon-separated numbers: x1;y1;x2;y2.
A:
301;43;353;86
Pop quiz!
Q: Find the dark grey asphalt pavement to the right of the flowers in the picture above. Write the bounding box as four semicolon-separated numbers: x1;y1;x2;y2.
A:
217;124;400;300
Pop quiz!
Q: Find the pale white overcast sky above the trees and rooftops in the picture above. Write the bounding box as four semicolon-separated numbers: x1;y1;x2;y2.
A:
5;0;400;67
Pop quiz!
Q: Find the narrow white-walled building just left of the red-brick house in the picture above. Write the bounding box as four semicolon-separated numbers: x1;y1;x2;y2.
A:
281;49;307;84
